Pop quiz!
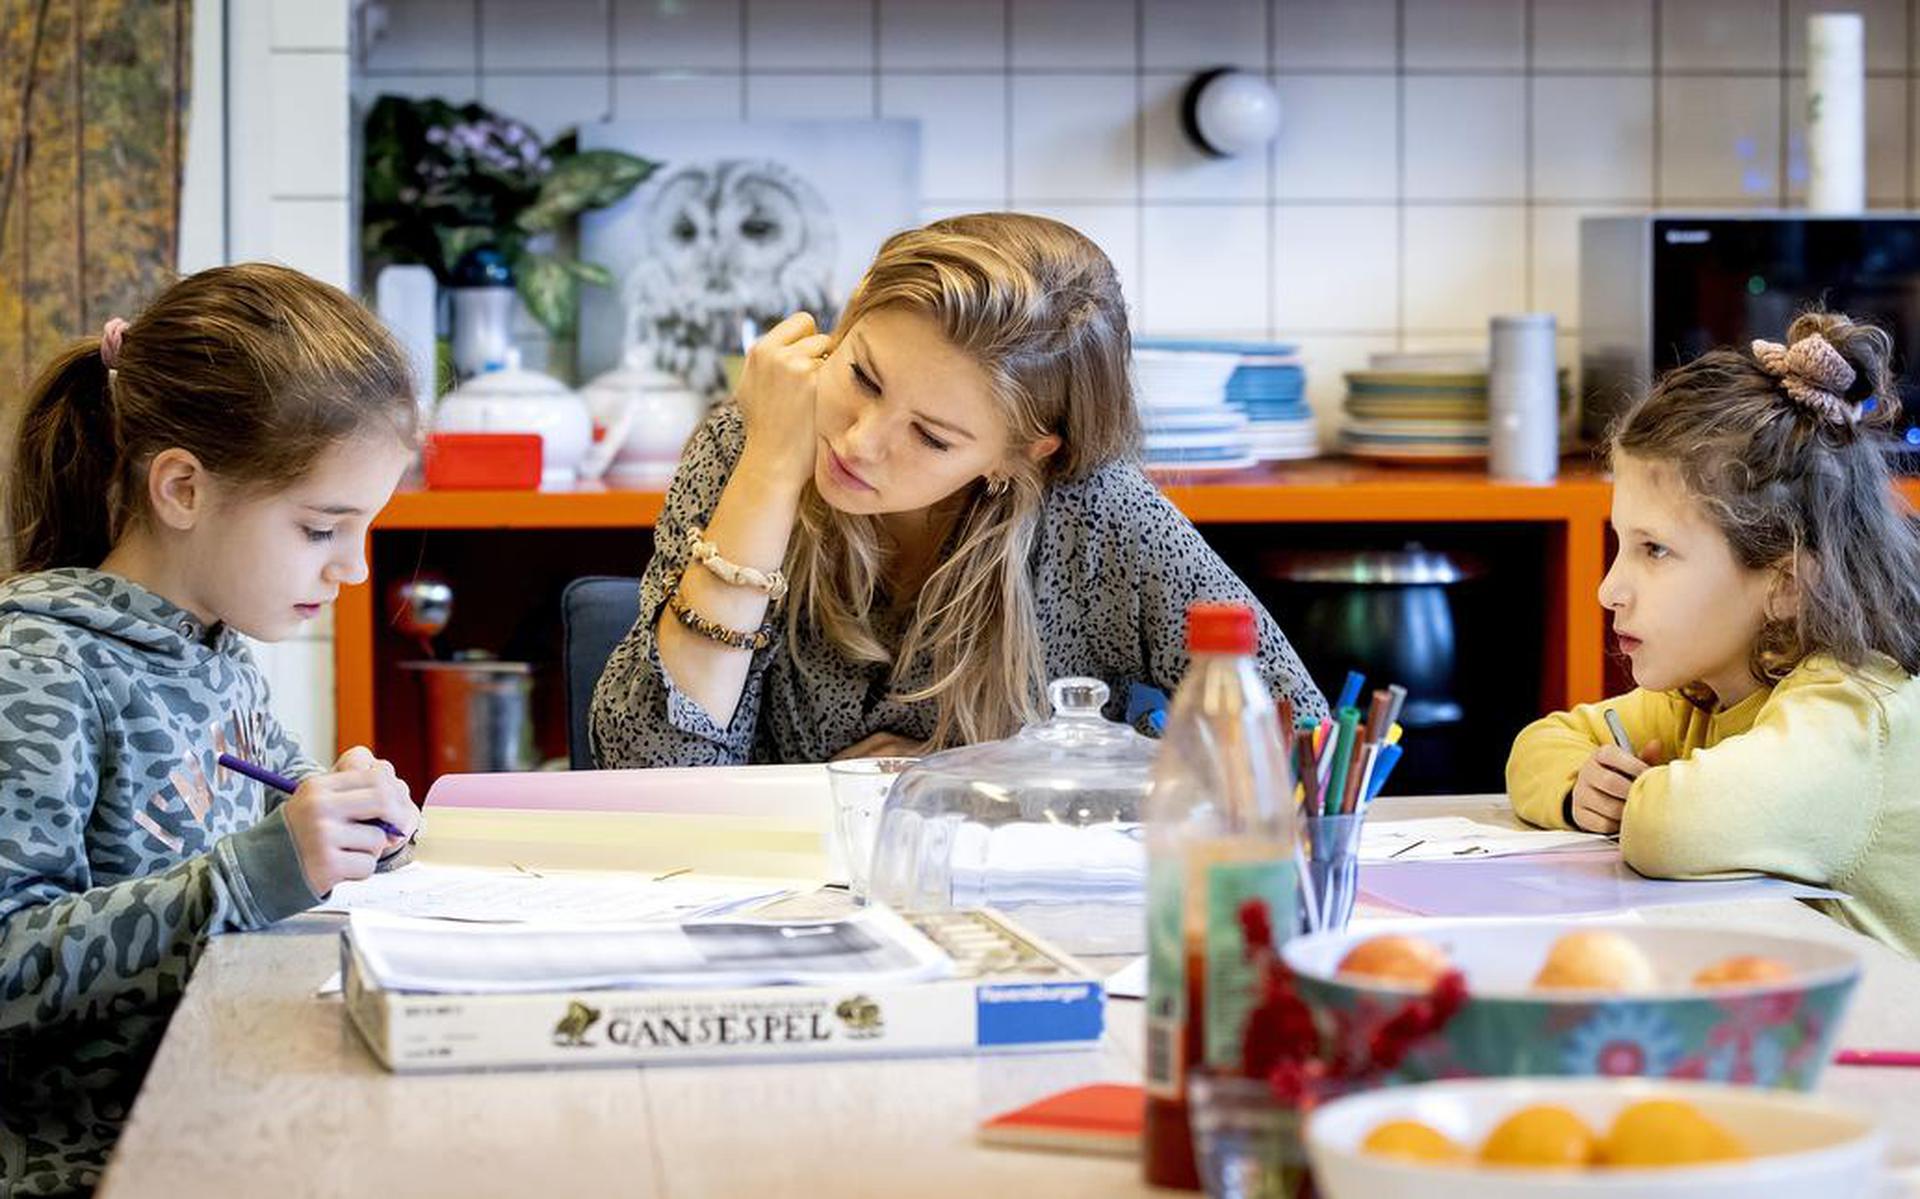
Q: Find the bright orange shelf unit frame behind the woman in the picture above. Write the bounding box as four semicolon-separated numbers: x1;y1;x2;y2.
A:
334;459;1920;747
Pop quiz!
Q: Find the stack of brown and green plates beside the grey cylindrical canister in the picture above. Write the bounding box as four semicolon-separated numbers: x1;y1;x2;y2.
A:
1340;354;1569;463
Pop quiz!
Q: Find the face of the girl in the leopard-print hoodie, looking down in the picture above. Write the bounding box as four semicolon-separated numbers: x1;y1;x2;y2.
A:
186;432;413;642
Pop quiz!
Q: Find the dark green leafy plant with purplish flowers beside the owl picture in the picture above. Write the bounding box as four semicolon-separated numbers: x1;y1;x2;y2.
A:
361;96;659;370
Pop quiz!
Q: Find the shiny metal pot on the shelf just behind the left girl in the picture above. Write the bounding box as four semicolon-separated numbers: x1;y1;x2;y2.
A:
401;659;538;778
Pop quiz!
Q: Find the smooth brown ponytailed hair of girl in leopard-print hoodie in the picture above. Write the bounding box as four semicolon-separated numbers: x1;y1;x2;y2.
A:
6;263;417;573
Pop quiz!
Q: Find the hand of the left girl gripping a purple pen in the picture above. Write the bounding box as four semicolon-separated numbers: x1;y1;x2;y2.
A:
282;746;420;895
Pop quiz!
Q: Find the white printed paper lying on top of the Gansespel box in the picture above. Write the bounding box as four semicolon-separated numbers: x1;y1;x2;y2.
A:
348;909;952;993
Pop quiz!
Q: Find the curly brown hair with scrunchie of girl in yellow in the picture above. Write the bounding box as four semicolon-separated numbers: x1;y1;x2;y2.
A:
1609;311;1920;701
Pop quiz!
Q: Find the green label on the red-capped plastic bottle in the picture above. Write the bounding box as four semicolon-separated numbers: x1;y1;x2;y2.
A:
1202;857;1300;1070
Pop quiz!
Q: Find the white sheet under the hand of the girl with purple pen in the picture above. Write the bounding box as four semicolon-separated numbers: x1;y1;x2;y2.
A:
315;861;789;924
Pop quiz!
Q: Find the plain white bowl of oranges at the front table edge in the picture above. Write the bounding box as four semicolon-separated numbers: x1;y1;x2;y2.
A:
1306;1078;1884;1199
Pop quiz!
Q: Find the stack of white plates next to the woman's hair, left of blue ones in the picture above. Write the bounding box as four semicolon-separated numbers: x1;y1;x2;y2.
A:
1133;342;1258;471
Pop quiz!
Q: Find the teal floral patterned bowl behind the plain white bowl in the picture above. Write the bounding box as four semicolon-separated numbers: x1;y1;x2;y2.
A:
1284;920;1860;1091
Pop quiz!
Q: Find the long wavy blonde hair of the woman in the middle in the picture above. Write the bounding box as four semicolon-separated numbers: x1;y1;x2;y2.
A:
787;213;1140;746
